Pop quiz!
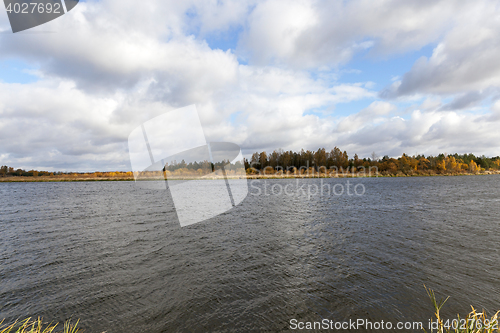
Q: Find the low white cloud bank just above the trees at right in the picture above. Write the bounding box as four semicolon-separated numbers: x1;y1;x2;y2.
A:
332;109;500;156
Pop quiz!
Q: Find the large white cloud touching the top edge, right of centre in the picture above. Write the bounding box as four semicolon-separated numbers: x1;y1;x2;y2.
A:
239;0;460;68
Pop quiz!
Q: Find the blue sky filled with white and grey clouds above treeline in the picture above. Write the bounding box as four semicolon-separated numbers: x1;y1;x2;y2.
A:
0;0;500;171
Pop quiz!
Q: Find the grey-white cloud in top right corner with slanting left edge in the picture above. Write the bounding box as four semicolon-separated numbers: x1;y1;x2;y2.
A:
382;1;500;99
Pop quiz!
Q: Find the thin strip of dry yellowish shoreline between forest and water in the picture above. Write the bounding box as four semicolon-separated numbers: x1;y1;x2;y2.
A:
0;170;500;183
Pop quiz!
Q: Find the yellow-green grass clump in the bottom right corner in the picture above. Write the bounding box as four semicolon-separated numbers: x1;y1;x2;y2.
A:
426;287;500;333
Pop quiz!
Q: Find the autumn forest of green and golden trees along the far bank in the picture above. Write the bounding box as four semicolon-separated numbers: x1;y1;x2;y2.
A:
0;147;500;179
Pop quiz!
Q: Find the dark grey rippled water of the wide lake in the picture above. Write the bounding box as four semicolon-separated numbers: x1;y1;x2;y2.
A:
0;175;500;332
